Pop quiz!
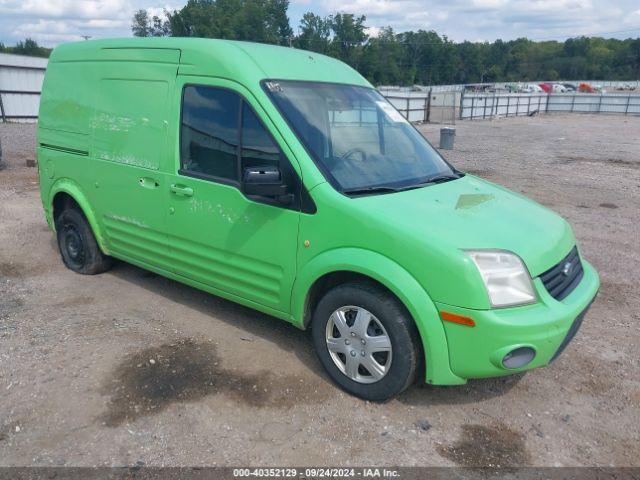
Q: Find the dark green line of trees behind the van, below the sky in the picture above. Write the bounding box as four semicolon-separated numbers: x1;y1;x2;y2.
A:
132;0;640;85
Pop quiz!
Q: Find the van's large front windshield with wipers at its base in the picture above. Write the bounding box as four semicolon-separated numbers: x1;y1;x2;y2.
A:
264;80;458;194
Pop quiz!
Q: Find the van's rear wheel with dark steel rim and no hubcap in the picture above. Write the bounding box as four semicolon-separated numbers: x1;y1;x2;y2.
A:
56;207;113;275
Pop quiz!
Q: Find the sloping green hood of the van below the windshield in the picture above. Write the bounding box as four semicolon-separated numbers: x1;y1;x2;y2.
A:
354;175;575;277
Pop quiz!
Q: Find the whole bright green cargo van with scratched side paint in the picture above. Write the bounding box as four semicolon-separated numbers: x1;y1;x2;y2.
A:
38;38;599;400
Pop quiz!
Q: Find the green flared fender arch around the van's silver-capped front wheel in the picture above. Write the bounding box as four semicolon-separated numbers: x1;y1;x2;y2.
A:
291;248;465;384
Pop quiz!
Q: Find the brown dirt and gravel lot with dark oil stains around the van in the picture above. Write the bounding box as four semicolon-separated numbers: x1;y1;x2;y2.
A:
0;115;640;466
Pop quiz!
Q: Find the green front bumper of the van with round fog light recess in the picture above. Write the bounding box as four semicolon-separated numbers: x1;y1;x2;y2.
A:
436;260;600;379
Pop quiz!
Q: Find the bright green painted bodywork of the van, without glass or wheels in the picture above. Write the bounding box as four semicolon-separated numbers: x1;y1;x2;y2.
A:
38;38;599;384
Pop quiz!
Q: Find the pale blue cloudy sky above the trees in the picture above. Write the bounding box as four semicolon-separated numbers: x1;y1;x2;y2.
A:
0;0;640;47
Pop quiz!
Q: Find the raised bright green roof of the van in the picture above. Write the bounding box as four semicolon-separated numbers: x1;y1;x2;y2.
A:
50;37;371;86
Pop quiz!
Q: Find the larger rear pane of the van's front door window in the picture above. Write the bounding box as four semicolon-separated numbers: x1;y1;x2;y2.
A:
180;86;240;181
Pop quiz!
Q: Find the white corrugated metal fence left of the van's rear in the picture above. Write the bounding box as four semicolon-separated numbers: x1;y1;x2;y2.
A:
0;53;47;122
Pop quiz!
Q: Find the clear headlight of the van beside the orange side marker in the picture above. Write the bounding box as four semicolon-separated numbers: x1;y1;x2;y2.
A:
466;250;536;307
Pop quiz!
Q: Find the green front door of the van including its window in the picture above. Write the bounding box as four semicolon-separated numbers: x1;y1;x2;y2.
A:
166;77;300;312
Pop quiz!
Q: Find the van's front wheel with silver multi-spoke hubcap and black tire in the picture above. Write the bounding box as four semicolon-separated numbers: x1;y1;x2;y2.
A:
311;282;422;401
